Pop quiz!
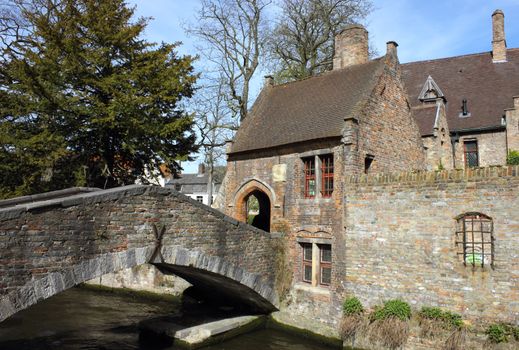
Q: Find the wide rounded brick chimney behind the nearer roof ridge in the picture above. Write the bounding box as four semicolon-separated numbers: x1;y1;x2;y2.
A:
333;24;368;70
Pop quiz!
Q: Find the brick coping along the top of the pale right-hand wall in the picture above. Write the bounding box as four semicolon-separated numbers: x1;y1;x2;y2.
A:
346;165;519;185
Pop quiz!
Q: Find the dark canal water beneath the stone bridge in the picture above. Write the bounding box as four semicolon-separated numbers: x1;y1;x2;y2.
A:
0;288;338;350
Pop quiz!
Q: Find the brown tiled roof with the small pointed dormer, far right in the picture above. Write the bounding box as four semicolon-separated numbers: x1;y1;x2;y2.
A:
402;49;519;132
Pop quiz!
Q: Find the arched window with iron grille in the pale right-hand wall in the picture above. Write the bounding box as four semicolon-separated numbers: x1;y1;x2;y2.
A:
456;213;494;267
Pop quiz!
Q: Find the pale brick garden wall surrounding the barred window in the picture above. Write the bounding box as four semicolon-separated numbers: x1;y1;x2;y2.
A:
344;166;519;322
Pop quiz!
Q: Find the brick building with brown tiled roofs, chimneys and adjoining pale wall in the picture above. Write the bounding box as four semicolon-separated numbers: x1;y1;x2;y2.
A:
220;10;519;329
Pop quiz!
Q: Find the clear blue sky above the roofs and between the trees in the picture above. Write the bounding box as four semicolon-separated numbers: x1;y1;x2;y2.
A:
128;0;519;172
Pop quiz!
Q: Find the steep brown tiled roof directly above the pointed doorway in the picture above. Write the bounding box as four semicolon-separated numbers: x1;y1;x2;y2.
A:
231;57;384;153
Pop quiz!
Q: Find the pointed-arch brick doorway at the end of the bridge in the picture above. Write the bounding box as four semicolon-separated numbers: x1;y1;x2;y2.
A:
234;179;276;232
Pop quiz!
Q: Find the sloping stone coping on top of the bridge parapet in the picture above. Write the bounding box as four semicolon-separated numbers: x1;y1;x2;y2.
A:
0;185;273;237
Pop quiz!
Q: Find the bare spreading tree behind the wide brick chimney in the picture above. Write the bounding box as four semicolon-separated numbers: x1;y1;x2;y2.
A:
269;0;373;81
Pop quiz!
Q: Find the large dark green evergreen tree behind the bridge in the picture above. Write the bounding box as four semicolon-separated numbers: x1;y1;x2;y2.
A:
0;0;196;198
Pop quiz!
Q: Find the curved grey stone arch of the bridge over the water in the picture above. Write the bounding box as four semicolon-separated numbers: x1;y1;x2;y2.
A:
0;246;279;322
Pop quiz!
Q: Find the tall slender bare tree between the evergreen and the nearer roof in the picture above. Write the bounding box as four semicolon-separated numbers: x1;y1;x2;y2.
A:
187;0;271;120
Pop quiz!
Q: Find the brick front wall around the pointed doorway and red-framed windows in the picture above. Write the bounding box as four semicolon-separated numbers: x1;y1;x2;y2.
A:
224;140;345;322
